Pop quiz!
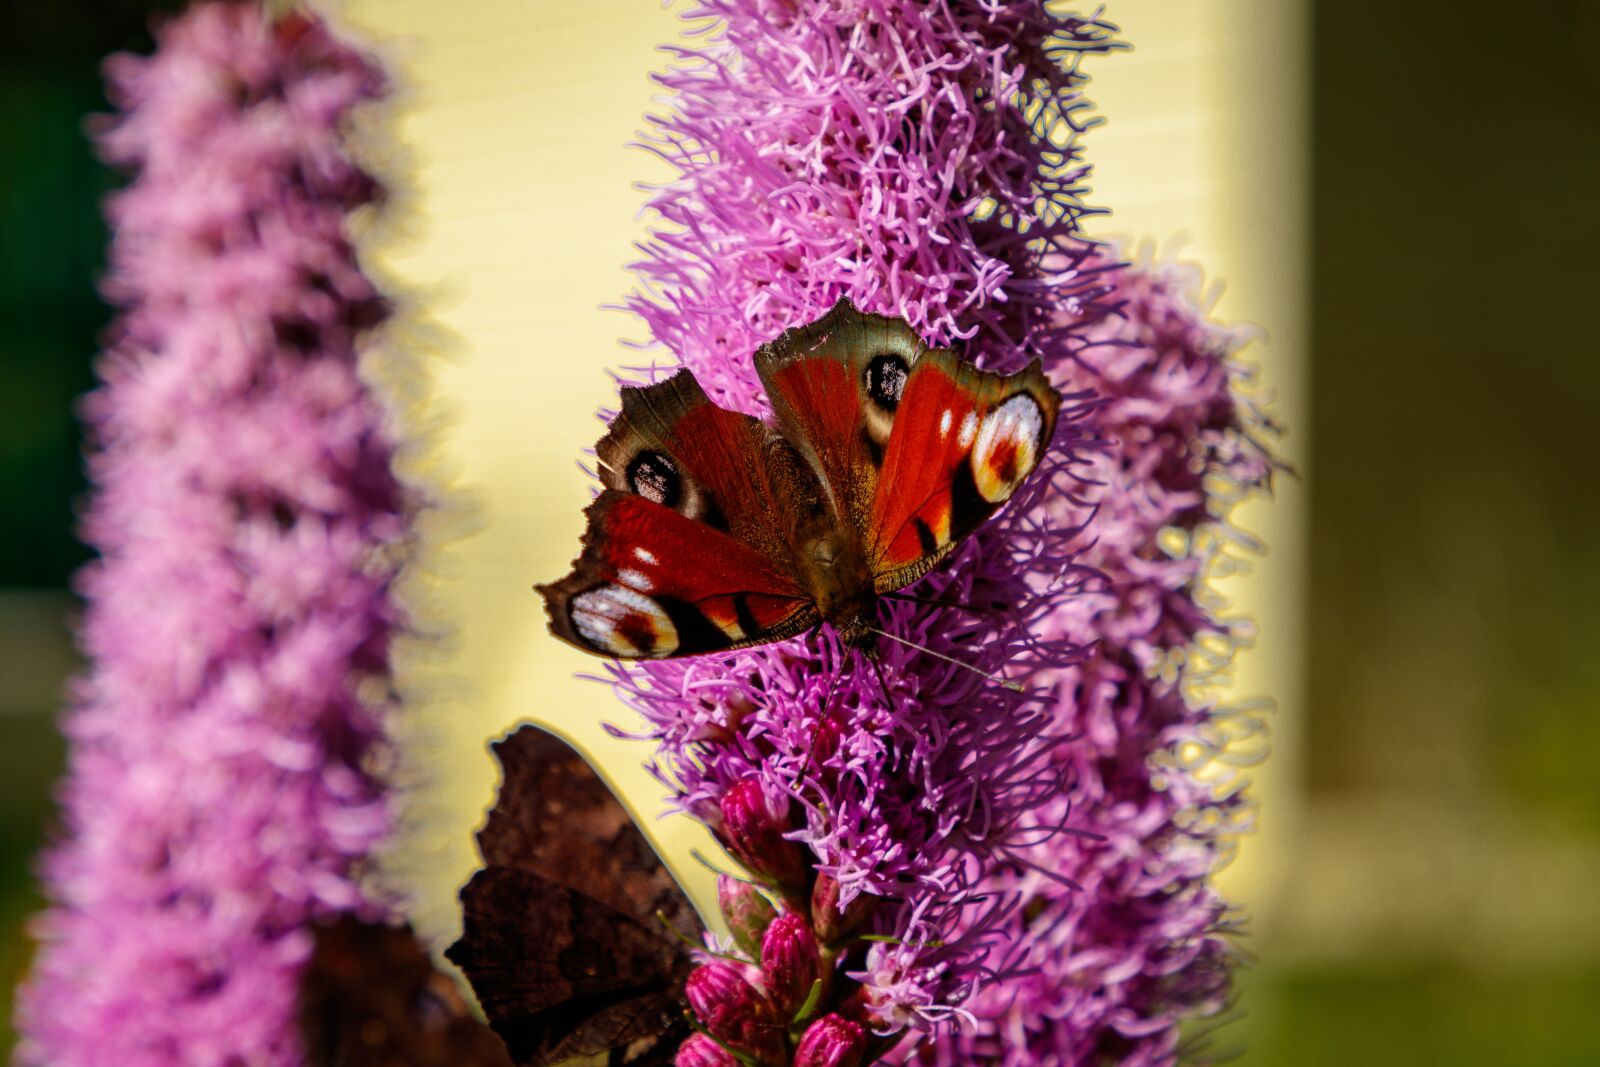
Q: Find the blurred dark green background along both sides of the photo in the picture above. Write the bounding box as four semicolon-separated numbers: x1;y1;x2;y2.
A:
0;0;1600;1065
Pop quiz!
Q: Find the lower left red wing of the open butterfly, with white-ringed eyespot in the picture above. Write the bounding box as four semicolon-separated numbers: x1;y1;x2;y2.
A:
539;490;818;659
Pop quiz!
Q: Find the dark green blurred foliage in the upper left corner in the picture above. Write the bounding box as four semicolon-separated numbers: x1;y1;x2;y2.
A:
0;0;176;587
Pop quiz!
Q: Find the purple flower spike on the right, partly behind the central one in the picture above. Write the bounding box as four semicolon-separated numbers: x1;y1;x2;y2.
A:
920;254;1274;1067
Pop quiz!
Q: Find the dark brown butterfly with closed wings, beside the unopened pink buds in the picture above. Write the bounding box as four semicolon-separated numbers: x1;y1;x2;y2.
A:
446;726;701;1067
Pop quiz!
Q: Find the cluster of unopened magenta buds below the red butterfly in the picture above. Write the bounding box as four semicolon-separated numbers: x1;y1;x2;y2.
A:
677;777;894;1067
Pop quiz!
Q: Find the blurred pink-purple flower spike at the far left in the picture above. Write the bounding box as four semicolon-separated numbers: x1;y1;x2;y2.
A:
19;3;406;1067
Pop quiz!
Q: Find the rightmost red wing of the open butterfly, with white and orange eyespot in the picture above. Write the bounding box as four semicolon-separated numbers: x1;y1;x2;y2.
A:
864;350;1061;592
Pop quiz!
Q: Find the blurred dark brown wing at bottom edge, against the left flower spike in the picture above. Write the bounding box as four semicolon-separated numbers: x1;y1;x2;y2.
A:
299;915;510;1067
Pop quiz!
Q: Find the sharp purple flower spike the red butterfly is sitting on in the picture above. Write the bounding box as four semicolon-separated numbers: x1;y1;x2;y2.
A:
601;0;1112;1049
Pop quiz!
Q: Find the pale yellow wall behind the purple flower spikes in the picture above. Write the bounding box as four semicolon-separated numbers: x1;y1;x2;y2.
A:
333;0;1304;939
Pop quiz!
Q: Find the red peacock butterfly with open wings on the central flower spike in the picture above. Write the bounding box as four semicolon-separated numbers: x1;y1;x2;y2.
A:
538;299;1061;659
